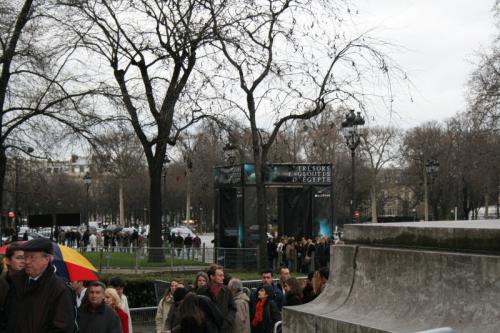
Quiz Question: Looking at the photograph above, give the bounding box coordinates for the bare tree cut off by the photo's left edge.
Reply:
[0,0,98,228]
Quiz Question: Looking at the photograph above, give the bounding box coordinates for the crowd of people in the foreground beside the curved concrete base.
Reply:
[156,265,329,333]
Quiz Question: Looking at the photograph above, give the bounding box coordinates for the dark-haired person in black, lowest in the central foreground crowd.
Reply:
[172,292,224,333]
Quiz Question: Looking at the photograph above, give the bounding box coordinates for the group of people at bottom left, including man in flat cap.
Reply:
[0,238,132,333]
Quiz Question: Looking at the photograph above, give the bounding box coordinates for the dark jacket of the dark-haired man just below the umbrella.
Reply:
[78,302,123,333]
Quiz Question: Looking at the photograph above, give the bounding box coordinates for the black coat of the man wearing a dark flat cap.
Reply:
[5,266,76,333]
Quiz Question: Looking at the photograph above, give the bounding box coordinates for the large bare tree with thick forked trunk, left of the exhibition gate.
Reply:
[59,0,229,260]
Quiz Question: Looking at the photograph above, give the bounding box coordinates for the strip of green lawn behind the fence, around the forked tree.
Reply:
[83,252,208,269]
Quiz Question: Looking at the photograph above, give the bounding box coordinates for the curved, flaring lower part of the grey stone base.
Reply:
[283,245,500,333]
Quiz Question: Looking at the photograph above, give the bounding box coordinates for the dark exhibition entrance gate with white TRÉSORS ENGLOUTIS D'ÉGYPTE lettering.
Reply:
[214,163,333,248]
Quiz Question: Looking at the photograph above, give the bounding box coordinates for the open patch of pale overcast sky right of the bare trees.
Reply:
[356,0,495,128]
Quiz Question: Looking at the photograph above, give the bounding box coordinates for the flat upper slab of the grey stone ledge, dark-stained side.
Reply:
[344,220,500,254]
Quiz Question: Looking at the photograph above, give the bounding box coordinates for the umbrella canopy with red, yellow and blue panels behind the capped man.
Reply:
[0,242,99,281]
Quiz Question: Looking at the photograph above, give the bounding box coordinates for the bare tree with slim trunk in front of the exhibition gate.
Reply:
[208,0,406,267]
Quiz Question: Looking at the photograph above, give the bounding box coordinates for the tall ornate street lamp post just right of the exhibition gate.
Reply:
[342,110,365,223]
